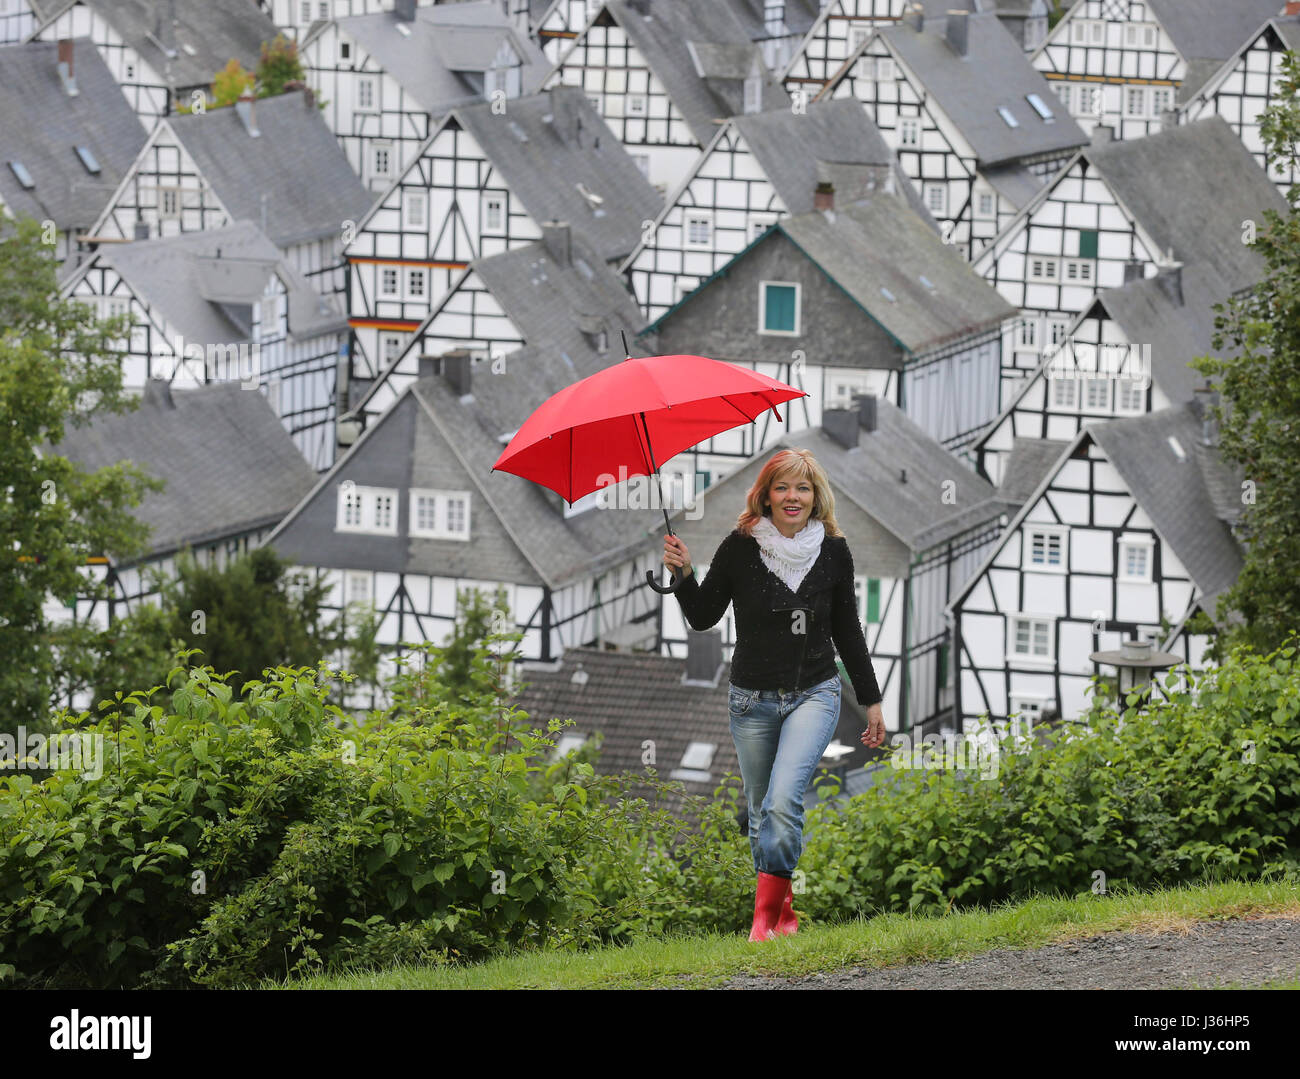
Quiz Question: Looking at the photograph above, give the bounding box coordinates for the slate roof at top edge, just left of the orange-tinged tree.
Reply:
[38,0,278,88]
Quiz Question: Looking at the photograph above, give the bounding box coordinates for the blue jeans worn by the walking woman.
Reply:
[728,673,840,876]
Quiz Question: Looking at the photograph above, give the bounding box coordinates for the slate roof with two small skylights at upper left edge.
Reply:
[0,38,147,239]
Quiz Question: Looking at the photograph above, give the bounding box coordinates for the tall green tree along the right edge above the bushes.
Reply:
[1191,52,1300,660]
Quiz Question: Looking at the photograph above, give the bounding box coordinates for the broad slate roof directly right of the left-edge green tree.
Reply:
[55,381,316,556]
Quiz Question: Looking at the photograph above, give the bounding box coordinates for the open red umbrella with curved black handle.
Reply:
[491,345,807,592]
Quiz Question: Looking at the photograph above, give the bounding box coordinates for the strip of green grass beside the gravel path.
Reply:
[259,881,1300,989]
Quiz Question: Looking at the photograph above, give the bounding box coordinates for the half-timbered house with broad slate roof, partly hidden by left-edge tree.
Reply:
[47,378,317,709]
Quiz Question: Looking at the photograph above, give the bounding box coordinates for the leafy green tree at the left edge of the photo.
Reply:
[0,218,159,731]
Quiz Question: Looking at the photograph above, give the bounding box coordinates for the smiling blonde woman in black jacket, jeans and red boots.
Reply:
[663,450,885,940]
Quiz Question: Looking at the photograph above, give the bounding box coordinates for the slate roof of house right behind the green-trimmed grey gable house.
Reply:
[738,100,911,213]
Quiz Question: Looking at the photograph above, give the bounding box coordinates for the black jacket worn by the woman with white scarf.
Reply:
[673,529,881,707]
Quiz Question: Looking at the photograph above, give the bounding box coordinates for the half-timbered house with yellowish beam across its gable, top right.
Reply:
[1032,0,1282,139]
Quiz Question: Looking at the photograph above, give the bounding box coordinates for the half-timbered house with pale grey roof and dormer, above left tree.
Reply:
[64,221,347,469]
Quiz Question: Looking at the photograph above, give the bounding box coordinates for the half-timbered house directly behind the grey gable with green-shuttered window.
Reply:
[620,101,919,320]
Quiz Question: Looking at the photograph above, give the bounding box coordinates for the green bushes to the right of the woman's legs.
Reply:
[800,642,1300,918]
